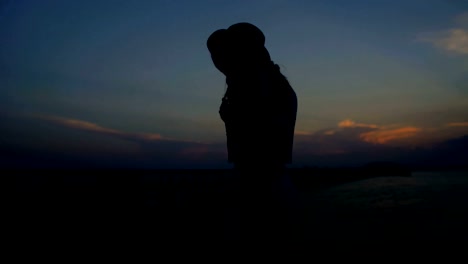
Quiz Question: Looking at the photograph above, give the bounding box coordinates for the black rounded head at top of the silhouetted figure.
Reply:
[207,22,271,76]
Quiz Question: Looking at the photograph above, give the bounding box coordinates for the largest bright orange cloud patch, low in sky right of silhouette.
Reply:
[360,127,421,144]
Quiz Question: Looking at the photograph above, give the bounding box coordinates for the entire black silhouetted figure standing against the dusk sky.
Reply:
[207,23,297,241]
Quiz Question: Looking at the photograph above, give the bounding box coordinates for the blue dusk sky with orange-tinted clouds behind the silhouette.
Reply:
[0,0,468,167]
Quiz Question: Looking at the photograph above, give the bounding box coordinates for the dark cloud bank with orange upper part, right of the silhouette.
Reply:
[294,119,468,167]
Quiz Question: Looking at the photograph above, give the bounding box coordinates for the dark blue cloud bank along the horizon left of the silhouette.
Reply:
[0,115,228,168]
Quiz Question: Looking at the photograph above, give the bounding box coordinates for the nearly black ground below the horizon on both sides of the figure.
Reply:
[2,170,468,242]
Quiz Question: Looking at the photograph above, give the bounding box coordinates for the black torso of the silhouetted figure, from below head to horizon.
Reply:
[220,65,297,168]
